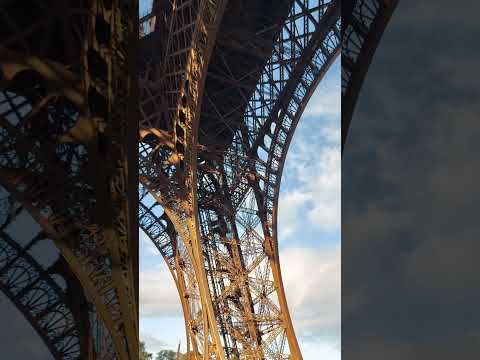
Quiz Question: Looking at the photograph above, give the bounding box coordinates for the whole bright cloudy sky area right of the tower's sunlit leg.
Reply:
[278,59,341,360]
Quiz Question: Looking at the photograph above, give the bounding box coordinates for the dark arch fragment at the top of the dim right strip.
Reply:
[342,0,399,152]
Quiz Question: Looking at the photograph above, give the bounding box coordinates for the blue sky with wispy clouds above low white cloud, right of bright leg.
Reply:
[278,57,341,243]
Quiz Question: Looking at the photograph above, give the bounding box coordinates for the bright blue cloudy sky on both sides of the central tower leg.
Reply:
[139,0,341,354]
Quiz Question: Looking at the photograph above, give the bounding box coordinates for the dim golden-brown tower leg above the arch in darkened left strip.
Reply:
[0,0,138,359]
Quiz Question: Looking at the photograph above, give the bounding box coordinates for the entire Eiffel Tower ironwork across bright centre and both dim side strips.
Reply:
[0,0,398,360]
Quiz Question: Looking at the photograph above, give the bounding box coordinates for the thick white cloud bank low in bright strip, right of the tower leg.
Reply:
[280,245,341,338]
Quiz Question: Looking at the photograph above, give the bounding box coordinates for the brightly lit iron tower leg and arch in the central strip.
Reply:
[139,0,341,359]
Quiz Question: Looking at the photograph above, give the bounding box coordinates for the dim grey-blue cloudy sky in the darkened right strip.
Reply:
[342,0,480,360]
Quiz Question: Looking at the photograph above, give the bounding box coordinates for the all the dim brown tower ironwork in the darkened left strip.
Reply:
[0,0,138,359]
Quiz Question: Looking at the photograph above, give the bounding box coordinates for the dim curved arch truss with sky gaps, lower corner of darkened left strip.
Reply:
[0,188,114,360]
